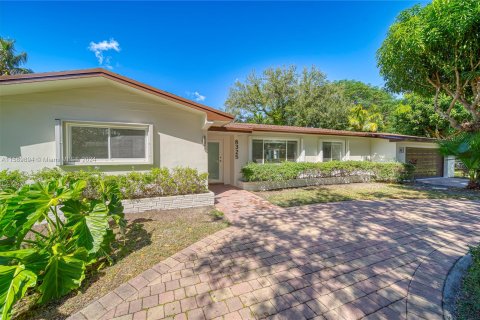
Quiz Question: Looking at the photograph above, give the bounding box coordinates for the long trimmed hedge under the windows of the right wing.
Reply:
[242,161,415,182]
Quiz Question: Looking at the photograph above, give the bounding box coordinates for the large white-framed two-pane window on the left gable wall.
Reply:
[66,122,151,163]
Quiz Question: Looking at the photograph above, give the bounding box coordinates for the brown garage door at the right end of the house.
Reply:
[406,148,443,178]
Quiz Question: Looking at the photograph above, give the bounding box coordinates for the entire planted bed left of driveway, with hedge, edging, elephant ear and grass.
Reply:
[0,168,220,320]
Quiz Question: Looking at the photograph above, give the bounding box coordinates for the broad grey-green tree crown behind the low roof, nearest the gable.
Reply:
[225,66,349,129]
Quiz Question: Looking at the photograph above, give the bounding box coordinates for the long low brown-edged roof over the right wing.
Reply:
[210,122,436,142]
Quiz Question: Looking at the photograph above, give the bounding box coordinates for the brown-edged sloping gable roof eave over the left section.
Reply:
[0,68,234,121]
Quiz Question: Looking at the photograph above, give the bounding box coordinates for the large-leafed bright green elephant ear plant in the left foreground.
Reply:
[0,178,126,319]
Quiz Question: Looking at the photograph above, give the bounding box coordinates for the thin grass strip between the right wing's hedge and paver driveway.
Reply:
[256,183,480,207]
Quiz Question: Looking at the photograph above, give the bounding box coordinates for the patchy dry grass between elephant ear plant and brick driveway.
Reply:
[14,207,228,320]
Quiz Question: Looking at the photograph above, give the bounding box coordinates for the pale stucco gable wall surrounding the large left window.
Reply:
[0,84,207,172]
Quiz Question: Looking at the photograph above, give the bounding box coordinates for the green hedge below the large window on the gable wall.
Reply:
[0,168,208,199]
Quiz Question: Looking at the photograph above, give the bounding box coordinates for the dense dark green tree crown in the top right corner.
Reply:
[377,0,480,131]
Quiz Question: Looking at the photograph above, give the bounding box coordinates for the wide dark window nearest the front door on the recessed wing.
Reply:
[251,139,298,163]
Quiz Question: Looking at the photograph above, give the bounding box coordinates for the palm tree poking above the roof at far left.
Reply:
[0,37,33,76]
